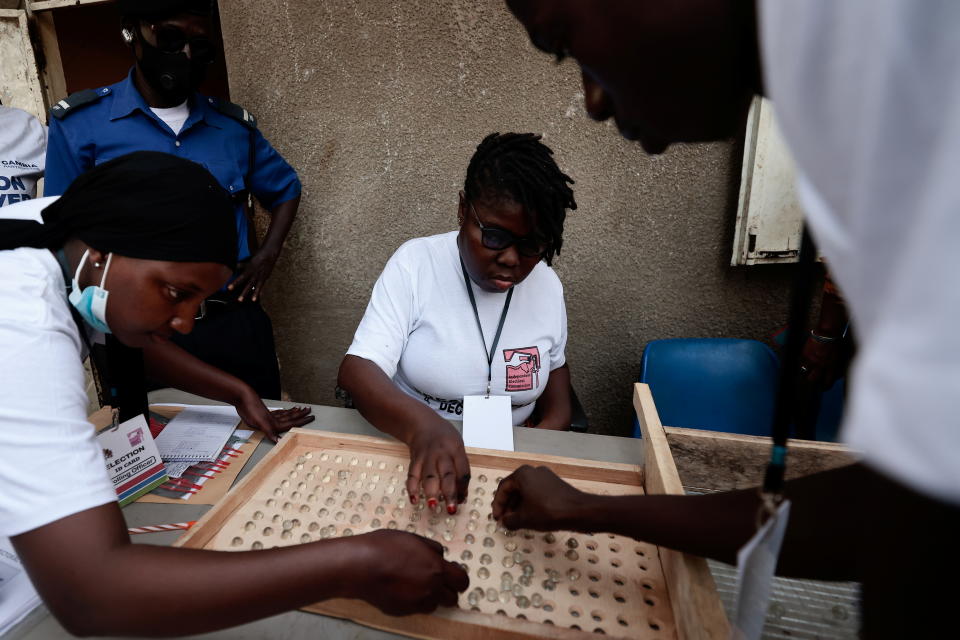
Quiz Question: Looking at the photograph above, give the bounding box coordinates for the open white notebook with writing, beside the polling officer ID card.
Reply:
[157,408,240,462]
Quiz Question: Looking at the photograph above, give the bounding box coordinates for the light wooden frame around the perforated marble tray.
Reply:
[175,384,730,640]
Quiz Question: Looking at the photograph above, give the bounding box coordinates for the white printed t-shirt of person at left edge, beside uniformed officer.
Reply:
[0,105,47,207]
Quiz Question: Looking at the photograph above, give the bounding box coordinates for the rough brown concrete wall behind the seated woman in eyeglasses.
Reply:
[221,0,788,434]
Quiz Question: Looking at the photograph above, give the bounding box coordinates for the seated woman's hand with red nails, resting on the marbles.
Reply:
[407,419,470,514]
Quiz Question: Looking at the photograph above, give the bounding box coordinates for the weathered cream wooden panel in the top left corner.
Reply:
[0,9,46,121]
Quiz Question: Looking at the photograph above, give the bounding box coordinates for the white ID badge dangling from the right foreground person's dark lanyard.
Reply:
[730,500,790,640]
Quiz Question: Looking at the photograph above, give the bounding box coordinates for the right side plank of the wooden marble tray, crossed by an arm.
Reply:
[633,383,730,640]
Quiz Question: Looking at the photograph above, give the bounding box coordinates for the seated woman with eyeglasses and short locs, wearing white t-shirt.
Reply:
[338,133,577,513]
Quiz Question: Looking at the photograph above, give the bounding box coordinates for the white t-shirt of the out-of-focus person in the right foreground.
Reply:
[760,0,960,504]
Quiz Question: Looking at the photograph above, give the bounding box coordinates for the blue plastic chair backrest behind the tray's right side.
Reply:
[634,338,779,436]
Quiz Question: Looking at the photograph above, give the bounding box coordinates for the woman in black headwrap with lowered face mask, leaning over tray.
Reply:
[0,152,467,635]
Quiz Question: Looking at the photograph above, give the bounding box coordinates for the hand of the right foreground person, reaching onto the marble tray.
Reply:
[493,464,589,531]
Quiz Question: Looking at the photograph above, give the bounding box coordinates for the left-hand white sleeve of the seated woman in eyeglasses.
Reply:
[347,246,417,379]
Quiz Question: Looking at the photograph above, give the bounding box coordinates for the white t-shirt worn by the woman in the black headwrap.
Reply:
[0,198,117,537]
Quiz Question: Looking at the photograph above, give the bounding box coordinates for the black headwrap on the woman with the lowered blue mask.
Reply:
[0,151,237,269]
